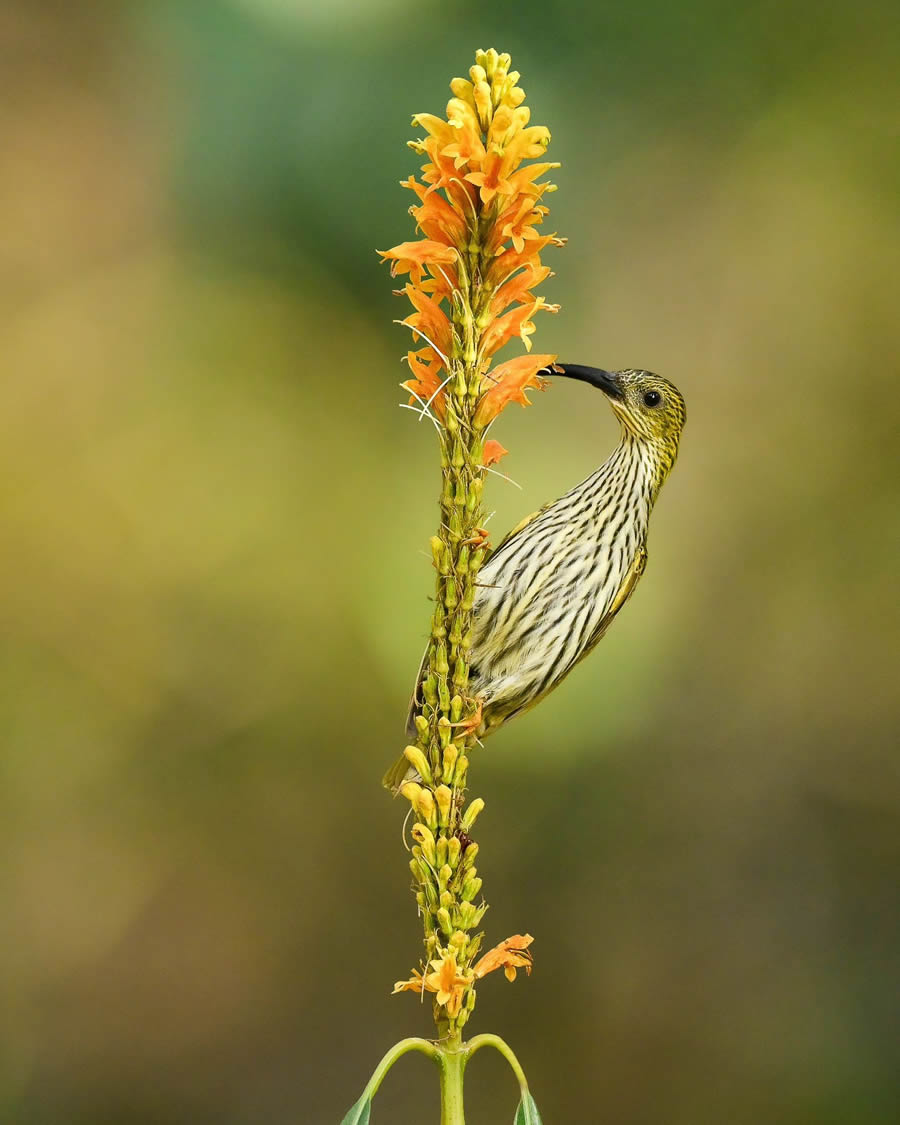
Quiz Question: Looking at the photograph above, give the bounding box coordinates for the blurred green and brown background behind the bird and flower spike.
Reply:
[0,0,900,1125]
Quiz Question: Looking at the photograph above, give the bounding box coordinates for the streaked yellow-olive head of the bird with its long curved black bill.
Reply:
[550,363,686,473]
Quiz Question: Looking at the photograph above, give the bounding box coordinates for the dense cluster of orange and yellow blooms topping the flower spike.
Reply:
[381,50,563,445]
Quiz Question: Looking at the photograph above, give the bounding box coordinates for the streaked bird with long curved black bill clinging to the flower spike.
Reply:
[384,363,686,792]
